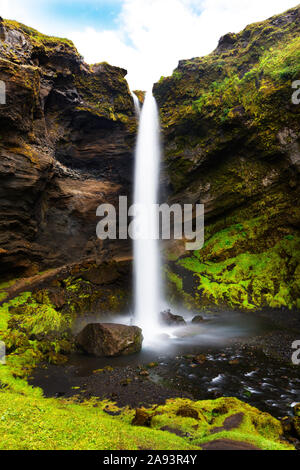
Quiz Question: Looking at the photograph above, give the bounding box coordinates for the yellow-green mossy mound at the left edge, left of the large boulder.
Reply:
[0,292,73,381]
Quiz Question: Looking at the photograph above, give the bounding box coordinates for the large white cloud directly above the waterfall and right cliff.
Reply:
[71,0,296,89]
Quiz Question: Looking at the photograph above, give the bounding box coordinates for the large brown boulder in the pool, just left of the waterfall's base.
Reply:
[76,323,143,357]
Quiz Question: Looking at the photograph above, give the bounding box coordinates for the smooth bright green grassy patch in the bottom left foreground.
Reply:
[0,391,195,450]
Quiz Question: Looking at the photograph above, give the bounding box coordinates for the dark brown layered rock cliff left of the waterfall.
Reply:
[0,20,136,278]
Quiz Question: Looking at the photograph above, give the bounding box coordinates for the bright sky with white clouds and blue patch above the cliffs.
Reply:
[0,0,299,90]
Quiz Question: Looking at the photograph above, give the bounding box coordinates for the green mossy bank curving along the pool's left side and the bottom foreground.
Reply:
[0,282,293,450]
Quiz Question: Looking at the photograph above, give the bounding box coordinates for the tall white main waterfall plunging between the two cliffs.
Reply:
[134,92,161,341]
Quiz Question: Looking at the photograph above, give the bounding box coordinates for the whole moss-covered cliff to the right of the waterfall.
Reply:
[154,6,300,309]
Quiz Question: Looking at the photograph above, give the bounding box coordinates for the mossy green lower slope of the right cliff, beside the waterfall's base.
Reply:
[167,206,300,310]
